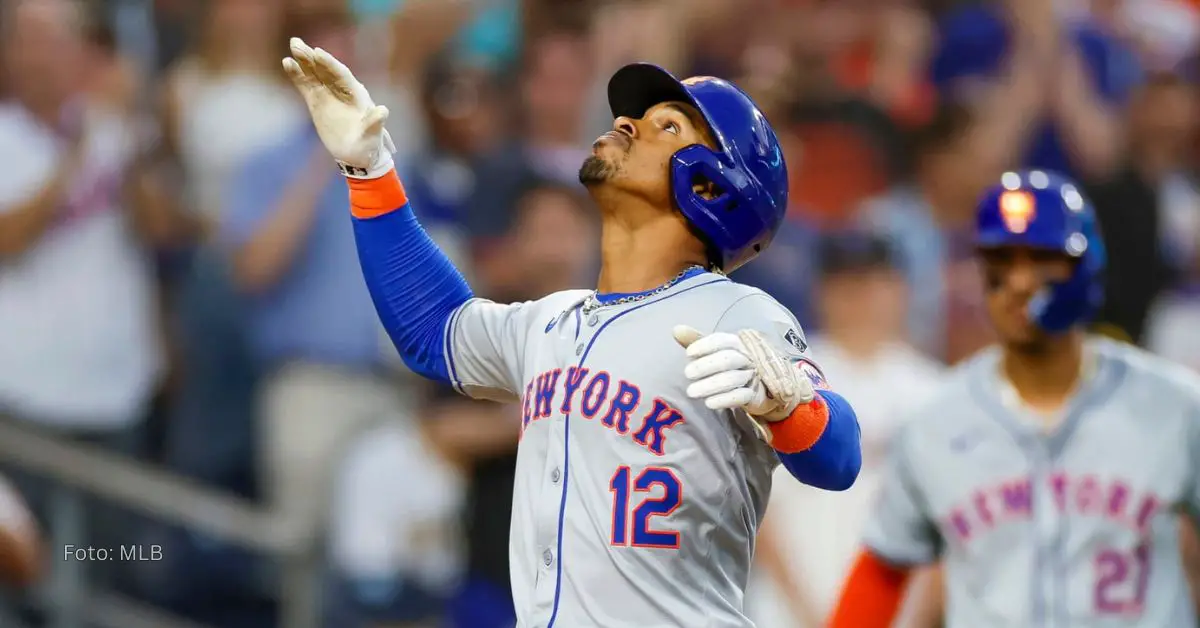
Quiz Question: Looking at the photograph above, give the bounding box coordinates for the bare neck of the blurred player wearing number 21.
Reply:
[1001,331,1084,412]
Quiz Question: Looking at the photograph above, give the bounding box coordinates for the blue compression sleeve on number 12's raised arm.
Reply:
[352,174,473,383]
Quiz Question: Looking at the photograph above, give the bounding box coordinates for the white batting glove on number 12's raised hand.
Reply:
[283,37,396,179]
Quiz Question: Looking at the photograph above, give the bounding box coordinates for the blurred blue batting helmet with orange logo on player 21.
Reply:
[976,171,1105,334]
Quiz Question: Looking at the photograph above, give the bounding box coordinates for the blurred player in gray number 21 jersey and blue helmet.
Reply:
[832,171,1200,628]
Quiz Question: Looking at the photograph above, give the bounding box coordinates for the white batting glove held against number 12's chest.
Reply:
[672,325,816,432]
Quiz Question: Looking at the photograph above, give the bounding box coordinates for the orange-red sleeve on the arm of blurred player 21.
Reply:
[827,551,908,628]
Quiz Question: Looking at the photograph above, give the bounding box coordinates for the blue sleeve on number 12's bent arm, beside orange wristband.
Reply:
[776,390,863,491]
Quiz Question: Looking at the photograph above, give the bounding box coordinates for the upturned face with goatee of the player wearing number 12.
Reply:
[580,102,716,208]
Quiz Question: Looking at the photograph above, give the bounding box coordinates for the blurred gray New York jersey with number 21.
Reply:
[866,339,1200,628]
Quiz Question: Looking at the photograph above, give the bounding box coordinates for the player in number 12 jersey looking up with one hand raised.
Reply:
[284,40,860,628]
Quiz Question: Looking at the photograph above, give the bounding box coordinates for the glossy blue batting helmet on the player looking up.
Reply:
[608,64,787,273]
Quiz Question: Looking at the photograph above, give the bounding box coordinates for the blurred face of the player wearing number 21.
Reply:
[979,246,1075,345]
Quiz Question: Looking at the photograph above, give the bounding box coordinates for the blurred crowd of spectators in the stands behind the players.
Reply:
[0,0,1200,628]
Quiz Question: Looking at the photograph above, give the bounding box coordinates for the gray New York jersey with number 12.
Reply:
[445,273,815,628]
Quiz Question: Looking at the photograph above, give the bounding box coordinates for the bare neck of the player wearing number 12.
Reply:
[596,206,704,294]
